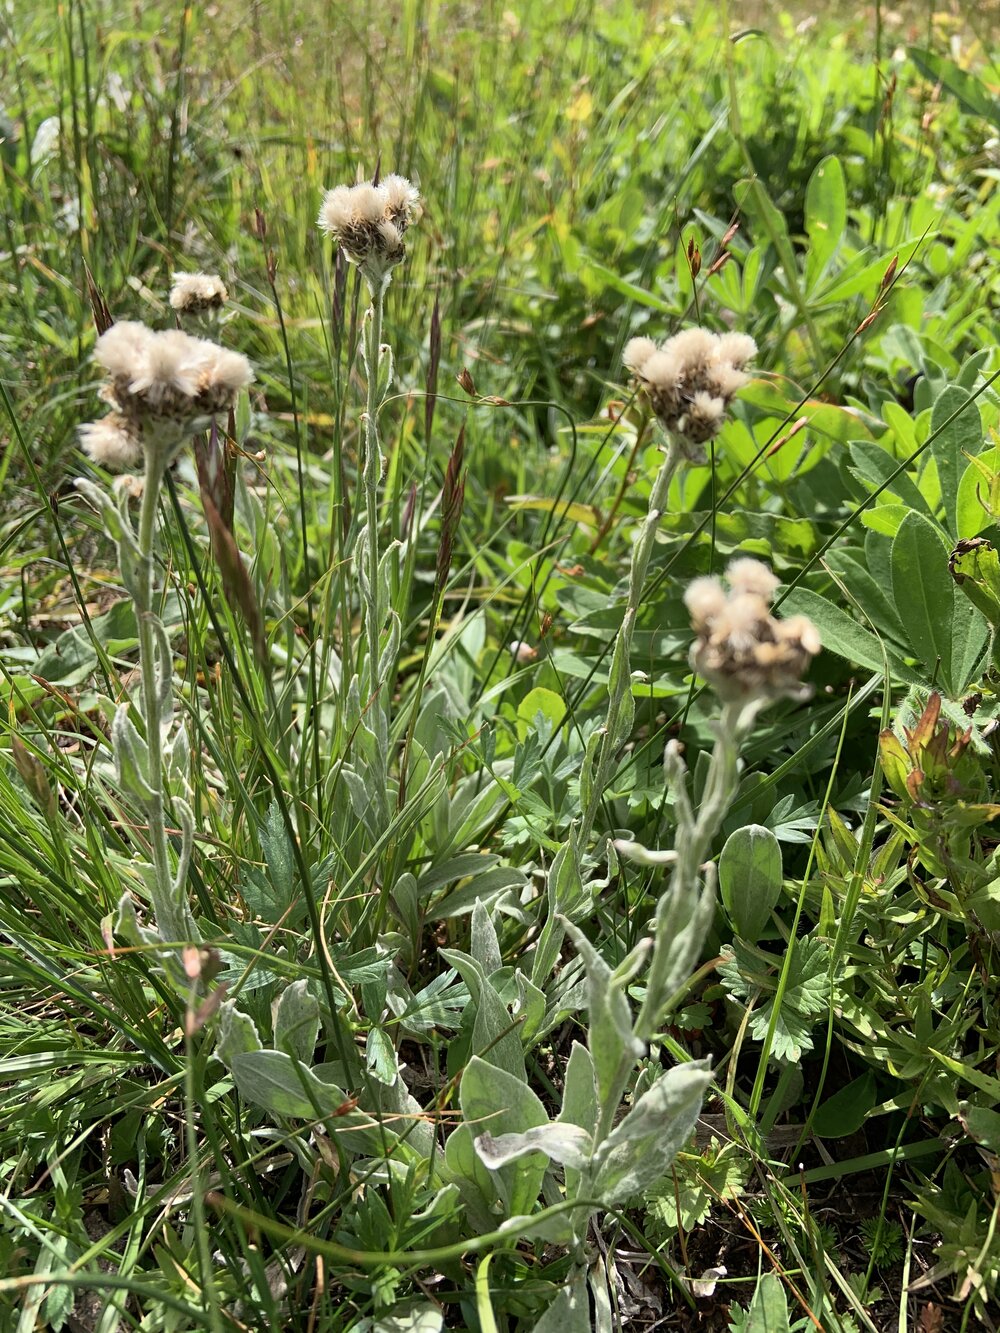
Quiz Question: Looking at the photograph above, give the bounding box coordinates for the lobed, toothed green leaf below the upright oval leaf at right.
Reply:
[719,940,829,1061]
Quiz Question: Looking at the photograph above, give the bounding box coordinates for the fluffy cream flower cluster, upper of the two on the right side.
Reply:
[624,328,757,448]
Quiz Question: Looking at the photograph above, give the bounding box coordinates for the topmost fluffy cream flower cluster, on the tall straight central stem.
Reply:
[319,176,420,275]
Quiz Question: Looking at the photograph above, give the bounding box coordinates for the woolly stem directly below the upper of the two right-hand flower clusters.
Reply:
[580,435,681,848]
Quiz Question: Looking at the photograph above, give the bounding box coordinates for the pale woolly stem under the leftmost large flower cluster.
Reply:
[132,448,200,941]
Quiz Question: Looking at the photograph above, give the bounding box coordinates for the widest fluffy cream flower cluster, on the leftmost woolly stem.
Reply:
[80,320,253,468]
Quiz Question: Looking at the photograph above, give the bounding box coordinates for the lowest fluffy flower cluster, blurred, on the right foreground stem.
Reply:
[684,557,820,701]
